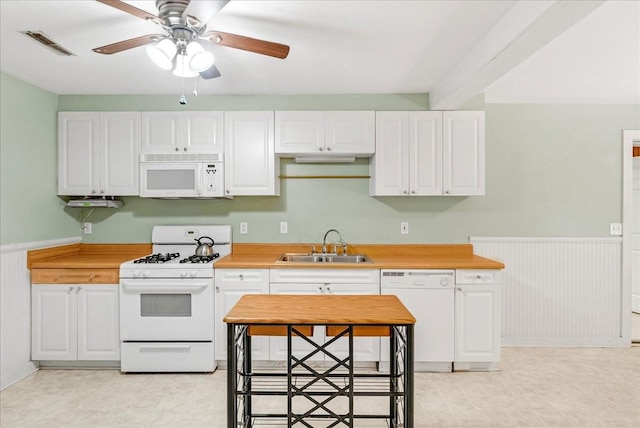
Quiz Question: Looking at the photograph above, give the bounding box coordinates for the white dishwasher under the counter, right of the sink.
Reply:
[380,269,455,372]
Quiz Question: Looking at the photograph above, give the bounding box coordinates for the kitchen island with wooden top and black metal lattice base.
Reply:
[224,294,415,428]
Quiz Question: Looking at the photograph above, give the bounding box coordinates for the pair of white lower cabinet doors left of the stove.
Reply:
[31,284,120,361]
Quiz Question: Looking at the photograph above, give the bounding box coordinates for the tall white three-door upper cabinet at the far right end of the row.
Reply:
[369,111,484,196]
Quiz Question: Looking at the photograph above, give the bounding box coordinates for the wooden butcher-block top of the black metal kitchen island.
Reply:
[223,294,416,326]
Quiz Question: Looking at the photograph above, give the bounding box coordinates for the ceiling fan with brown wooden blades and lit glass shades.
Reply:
[93,0,289,79]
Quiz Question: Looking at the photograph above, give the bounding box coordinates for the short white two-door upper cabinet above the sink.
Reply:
[275,111,375,157]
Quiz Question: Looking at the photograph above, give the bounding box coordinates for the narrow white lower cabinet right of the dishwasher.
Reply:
[454,270,502,370]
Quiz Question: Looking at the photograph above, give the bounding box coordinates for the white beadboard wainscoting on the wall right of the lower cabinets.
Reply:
[469,237,631,346]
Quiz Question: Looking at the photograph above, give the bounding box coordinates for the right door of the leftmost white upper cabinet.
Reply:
[99,112,140,196]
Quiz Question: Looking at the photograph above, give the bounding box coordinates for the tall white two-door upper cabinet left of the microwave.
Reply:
[58,112,140,196]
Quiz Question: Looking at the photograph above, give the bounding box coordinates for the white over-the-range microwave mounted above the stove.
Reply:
[140,153,224,198]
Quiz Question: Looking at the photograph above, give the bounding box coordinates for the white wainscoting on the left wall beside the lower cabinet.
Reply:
[0,238,80,390]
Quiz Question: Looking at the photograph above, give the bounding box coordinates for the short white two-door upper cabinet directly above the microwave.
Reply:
[142,111,224,154]
